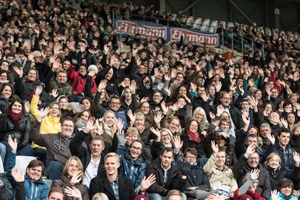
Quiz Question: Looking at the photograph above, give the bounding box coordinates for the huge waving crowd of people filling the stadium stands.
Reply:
[0,0,300,200]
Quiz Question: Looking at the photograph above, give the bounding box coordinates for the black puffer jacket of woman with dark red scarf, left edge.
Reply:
[0,114,30,149]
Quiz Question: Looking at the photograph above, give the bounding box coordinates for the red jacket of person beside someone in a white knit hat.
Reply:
[67,65,97,95]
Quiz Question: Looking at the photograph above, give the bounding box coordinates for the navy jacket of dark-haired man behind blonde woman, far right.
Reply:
[265,143,295,172]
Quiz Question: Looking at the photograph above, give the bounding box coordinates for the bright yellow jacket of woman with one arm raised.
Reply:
[30,95,61,149]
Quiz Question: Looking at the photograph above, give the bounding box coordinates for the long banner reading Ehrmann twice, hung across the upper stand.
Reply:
[114,20,220,47]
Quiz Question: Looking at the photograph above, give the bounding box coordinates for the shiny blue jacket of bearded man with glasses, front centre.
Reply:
[116,145,147,189]
